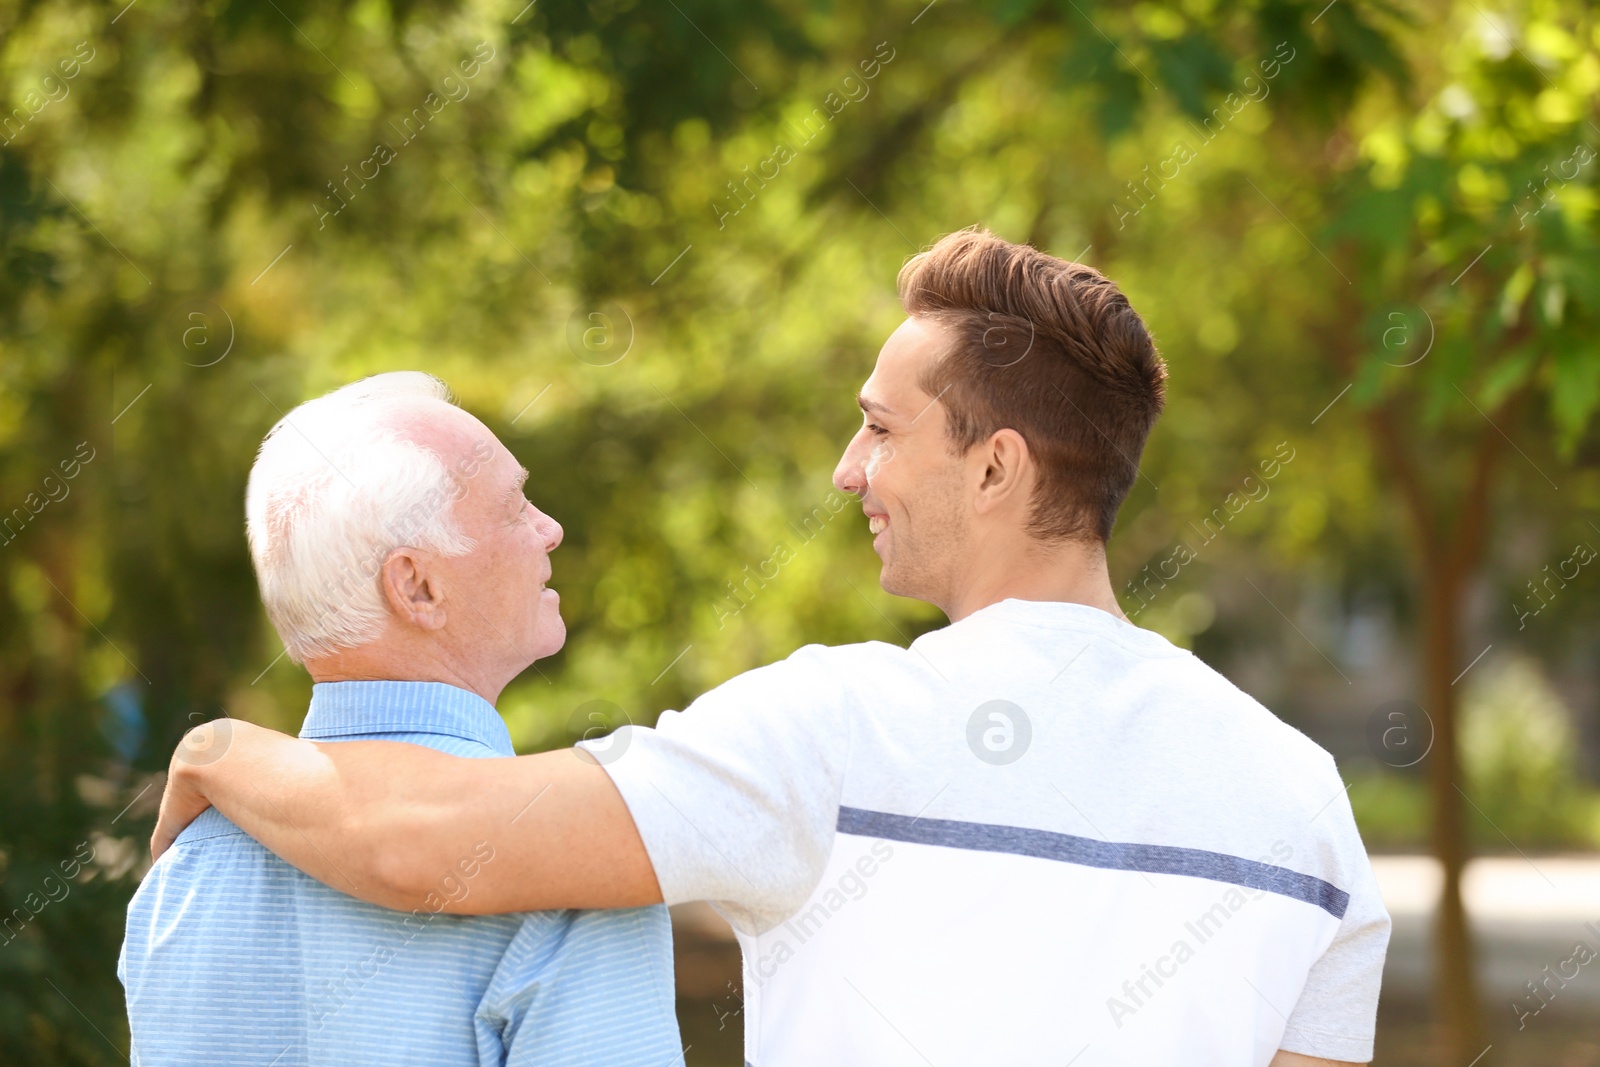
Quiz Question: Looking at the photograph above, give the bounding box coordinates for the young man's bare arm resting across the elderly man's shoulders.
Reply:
[150,720,661,915]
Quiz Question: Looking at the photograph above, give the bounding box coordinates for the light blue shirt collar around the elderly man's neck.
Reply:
[301,681,515,755]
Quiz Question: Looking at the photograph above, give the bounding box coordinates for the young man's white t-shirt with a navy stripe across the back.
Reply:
[589,600,1389,1067]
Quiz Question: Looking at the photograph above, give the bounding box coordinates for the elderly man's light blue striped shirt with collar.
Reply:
[117,681,683,1067]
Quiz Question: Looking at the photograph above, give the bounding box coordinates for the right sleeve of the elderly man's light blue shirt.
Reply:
[475,904,683,1067]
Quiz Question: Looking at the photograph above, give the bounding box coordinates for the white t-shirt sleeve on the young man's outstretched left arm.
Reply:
[579,645,850,936]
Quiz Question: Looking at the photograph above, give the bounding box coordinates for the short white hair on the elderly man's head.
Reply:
[245,371,486,662]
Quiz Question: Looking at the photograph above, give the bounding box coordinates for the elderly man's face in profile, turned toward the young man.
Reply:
[400,403,566,677]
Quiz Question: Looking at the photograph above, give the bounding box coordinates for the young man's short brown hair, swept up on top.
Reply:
[899,227,1166,542]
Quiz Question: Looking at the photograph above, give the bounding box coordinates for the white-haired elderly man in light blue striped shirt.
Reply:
[118,373,680,1067]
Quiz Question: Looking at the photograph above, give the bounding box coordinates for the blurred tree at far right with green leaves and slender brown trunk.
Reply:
[1291,3,1600,1059]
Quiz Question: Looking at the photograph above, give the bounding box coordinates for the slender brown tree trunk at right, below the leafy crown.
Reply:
[1422,555,1485,1067]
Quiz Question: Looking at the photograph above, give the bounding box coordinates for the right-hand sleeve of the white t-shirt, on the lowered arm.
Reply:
[1280,783,1389,1064]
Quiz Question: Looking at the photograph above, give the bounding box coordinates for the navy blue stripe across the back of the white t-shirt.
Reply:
[838,808,1350,918]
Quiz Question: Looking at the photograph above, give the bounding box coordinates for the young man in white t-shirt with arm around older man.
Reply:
[152,230,1389,1067]
